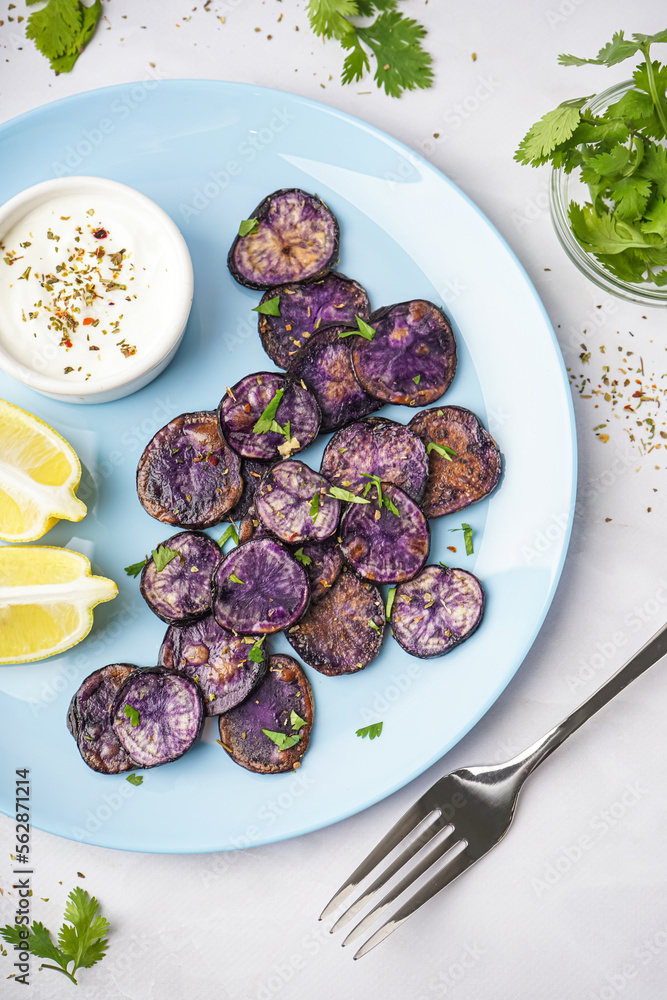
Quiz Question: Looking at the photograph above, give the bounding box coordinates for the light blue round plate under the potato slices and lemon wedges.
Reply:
[0,80,576,852]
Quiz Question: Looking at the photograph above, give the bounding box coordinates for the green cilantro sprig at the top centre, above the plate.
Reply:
[308,0,433,97]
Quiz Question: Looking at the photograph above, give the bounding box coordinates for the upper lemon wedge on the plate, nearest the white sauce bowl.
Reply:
[0,399,86,542]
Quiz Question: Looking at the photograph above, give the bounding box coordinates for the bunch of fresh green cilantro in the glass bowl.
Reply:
[515,30,667,285]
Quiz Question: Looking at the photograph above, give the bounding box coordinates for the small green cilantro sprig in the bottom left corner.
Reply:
[0,886,110,986]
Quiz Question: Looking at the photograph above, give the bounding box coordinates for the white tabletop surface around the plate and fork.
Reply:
[0,0,667,1000]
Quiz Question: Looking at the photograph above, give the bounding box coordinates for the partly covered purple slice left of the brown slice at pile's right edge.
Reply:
[320,417,428,502]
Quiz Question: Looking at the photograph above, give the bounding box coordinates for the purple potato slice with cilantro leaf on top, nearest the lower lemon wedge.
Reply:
[140,531,222,625]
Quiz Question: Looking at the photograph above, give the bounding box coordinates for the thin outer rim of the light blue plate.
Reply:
[0,77,578,855]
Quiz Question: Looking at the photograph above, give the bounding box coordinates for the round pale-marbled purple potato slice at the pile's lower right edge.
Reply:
[391,566,484,657]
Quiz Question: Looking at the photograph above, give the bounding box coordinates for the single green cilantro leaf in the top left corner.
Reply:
[26,0,102,76]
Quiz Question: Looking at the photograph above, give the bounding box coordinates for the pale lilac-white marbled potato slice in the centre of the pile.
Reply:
[255,459,340,545]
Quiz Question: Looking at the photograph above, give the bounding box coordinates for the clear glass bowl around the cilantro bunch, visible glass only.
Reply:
[549,80,667,306]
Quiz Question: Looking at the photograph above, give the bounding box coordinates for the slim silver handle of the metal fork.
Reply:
[505,625,667,777]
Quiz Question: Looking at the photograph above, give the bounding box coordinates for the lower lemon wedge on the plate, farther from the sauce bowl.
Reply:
[0,545,118,664]
